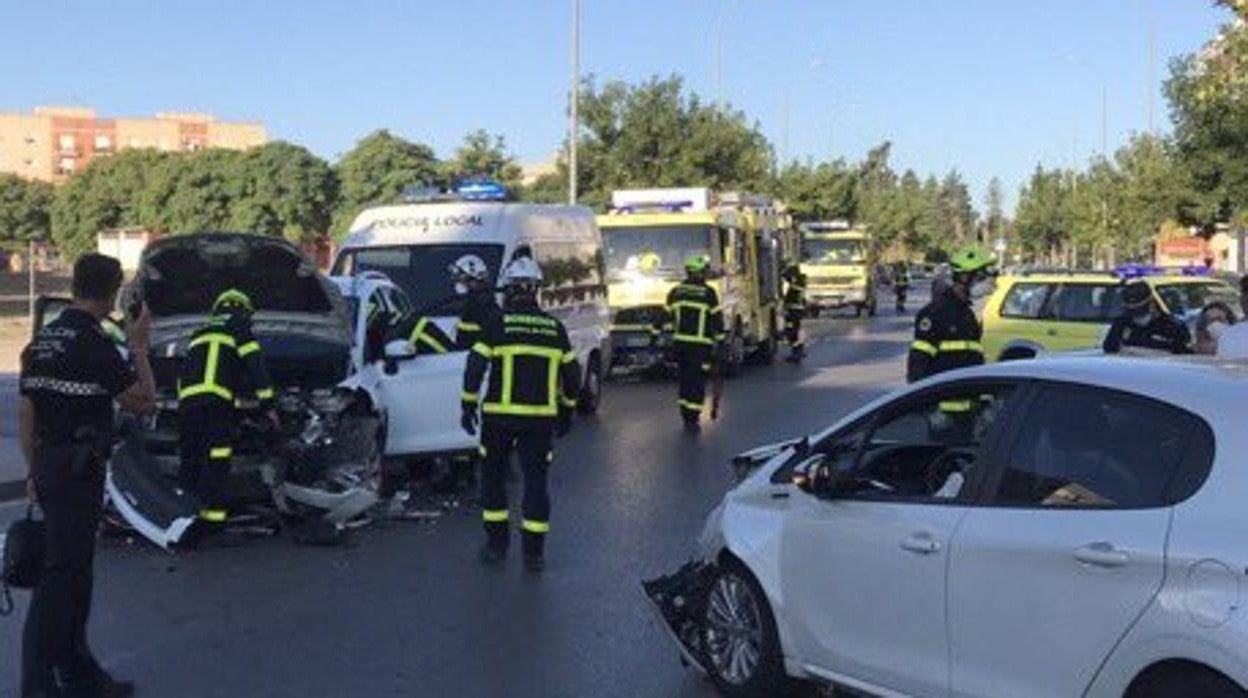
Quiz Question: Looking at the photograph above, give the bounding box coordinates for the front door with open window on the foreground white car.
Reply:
[781,385,1012,696]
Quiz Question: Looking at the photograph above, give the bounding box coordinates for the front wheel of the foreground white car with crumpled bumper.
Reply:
[701,559,790,698]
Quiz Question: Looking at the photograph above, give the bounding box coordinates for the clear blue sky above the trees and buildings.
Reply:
[0,0,1227,213]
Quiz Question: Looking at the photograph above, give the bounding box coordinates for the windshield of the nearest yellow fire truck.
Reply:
[603,225,711,281]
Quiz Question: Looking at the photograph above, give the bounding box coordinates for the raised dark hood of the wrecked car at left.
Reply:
[126,232,352,387]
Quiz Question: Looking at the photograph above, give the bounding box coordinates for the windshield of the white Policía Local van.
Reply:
[333,243,503,316]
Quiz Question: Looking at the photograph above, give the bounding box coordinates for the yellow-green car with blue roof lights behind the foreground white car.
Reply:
[983,271,1239,361]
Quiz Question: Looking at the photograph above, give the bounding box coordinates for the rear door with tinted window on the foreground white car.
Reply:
[948,386,1196,698]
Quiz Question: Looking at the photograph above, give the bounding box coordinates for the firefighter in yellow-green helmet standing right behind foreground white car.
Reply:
[906,247,993,384]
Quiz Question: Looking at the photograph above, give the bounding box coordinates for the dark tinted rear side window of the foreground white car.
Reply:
[992,385,1213,508]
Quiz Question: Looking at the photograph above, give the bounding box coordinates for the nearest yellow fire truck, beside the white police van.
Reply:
[598,187,799,373]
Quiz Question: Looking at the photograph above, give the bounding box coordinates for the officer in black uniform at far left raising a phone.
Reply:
[19,253,156,697]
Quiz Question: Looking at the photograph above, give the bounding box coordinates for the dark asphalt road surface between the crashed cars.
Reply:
[0,293,915,698]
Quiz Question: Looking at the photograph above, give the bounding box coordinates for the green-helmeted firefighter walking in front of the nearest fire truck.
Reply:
[668,255,725,433]
